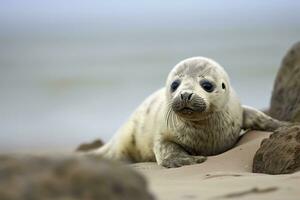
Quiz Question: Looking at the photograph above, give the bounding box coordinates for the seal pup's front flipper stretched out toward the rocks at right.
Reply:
[242,106,290,131]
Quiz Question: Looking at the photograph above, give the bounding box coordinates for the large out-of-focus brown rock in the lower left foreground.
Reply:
[0,155,153,200]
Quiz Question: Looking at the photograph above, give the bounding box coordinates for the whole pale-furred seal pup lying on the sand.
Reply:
[91,57,285,168]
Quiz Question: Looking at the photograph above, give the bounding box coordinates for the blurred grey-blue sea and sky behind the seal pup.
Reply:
[0,0,300,152]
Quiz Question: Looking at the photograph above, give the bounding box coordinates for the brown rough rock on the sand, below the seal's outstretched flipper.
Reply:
[253,125,300,174]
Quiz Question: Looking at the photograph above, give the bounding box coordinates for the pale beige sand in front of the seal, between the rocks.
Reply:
[131,131,300,200]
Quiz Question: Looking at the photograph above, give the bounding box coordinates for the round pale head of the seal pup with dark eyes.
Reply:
[166,57,230,121]
